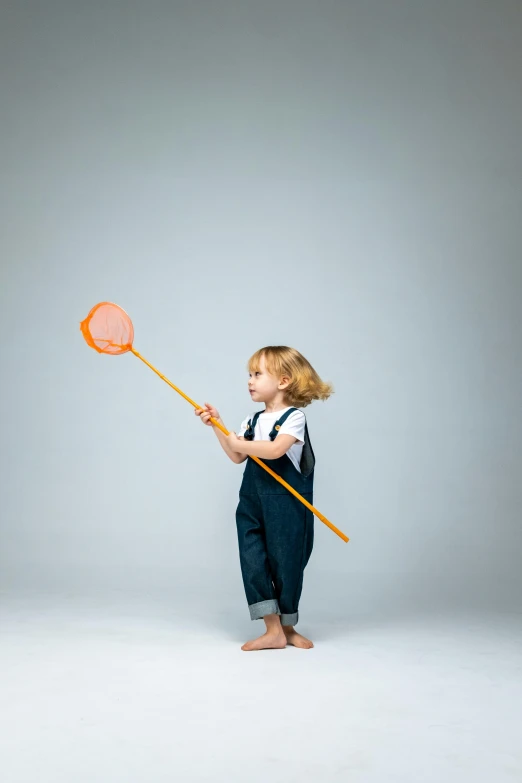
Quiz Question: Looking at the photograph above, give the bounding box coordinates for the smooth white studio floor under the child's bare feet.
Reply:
[0,591,522,783]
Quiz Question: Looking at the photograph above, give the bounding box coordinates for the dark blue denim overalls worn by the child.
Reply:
[236,408,315,625]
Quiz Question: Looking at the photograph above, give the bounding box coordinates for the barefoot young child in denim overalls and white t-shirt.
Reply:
[195,346,333,651]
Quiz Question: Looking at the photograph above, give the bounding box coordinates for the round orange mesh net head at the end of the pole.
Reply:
[80,302,134,356]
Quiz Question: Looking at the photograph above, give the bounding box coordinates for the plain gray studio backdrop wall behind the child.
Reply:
[0,0,522,619]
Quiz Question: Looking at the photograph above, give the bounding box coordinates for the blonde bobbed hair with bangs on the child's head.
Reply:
[248,345,334,408]
